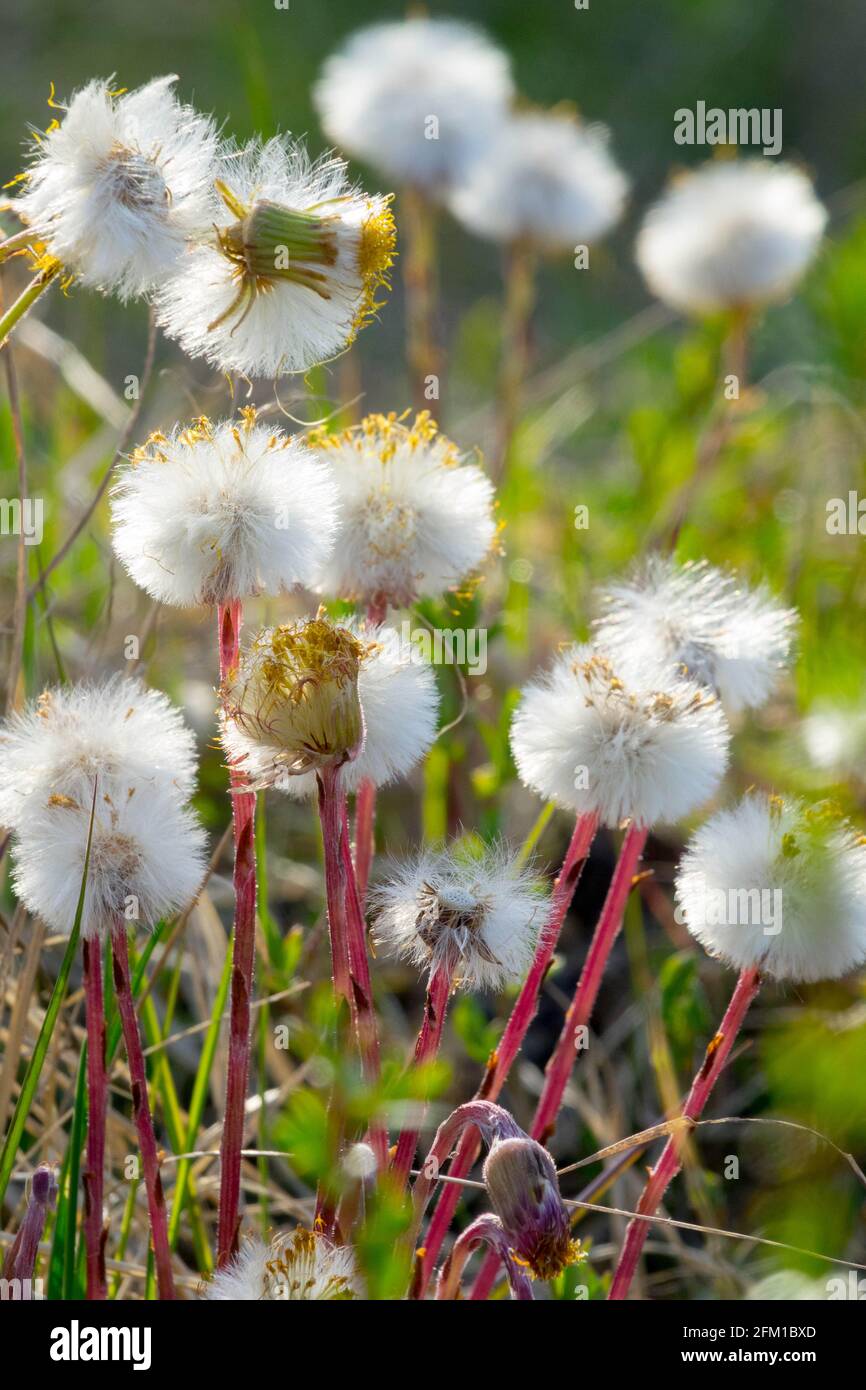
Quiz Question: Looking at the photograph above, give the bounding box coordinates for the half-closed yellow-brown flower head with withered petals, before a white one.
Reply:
[221,616,364,788]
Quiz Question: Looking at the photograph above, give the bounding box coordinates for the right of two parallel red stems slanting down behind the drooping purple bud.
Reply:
[473,824,649,1298]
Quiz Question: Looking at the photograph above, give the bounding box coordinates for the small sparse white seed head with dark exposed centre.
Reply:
[371,845,546,990]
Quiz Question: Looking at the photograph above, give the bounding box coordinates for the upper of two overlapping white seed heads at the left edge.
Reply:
[0,676,196,830]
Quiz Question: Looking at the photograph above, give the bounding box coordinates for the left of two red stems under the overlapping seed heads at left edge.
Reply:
[82,937,108,1300]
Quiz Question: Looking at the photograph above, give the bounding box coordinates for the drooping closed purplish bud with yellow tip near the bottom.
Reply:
[484,1134,581,1279]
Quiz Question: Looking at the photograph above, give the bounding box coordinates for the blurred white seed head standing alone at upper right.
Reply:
[635,158,827,314]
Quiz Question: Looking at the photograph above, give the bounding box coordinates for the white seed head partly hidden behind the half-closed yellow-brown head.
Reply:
[268,619,439,798]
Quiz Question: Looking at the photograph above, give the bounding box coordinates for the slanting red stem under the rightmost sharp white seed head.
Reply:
[607,969,760,1301]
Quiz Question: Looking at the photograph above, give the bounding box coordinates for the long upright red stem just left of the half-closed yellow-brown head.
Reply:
[217,600,256,1268]
